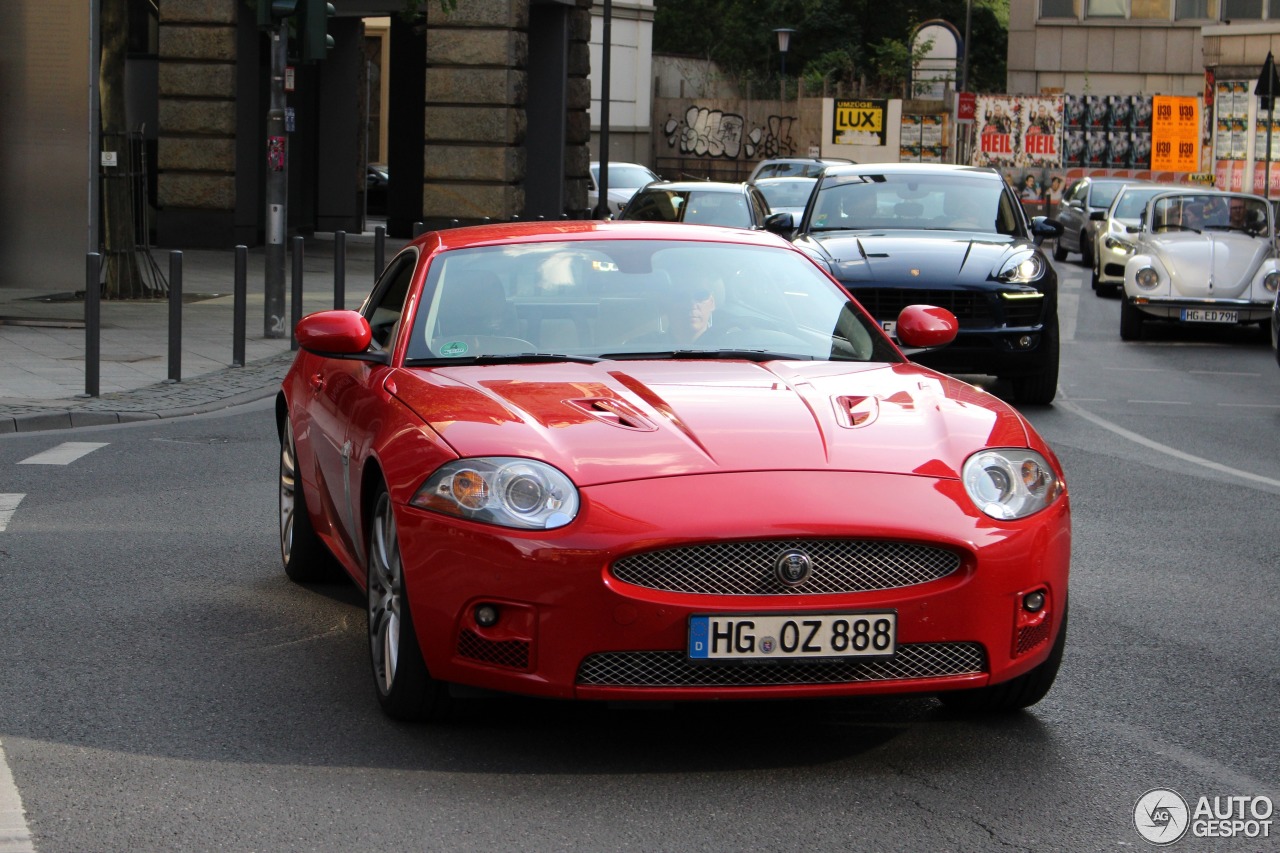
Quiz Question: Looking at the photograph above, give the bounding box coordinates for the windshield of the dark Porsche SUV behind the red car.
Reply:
[809,173,1023,234]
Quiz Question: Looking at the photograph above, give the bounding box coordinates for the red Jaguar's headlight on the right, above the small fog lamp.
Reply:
[960,448,1062,520]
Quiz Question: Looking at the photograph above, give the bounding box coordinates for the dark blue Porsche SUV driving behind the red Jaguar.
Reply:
[795,163,1061,405]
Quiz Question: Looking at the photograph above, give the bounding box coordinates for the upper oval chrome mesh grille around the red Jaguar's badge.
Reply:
[611,539,960,596]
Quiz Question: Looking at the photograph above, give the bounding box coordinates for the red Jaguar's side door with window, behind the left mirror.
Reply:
[308,248,419,560]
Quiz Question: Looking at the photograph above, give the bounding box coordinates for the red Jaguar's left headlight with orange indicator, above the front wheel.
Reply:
[410,456,579,530]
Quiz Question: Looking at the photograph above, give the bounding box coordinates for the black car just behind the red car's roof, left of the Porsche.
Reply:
[618,181,791,231]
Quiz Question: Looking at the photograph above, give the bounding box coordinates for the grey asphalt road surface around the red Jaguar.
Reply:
[0,258,1280,853]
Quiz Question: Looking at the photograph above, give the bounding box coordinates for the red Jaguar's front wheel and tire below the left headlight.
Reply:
[367,485,448,721]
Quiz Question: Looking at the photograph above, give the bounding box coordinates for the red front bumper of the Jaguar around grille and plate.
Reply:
[398,471,1070,701]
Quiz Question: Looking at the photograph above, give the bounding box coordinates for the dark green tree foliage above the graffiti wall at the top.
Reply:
[653,0,1009,96]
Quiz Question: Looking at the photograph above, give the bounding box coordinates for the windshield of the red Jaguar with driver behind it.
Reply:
[407,240,901,362]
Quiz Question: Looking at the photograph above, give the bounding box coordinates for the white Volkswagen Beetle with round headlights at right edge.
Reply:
[1120,190,1280,341]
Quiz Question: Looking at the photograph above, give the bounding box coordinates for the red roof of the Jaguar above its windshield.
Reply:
[410,219,803,254]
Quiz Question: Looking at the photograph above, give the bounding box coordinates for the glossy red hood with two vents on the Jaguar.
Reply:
[387,361,1028,484]
